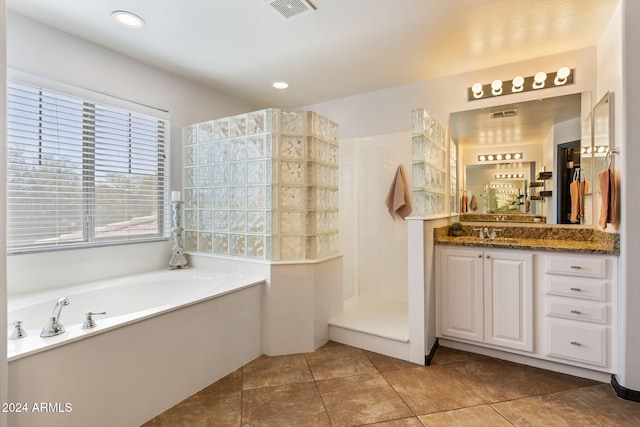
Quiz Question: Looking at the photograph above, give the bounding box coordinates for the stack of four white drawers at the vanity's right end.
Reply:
[544,254,616,370]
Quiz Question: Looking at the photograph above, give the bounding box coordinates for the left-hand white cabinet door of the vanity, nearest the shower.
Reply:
[437,248,484,342]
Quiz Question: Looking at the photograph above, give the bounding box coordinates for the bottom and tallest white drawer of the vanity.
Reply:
[547,320,607,367]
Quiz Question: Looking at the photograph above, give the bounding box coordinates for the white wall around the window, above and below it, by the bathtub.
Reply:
[2,13,256,293]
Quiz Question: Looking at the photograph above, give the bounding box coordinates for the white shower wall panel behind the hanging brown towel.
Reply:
[340,131,412,303]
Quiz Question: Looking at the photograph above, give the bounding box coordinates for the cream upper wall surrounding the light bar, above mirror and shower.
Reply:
[303,48,596,138]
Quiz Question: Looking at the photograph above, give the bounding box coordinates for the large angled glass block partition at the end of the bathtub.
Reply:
[183,108,339,260]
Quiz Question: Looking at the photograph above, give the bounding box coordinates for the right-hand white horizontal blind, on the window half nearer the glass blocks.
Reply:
[94,105,165,240]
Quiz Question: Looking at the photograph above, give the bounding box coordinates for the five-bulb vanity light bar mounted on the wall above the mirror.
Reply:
[467,67,575,101]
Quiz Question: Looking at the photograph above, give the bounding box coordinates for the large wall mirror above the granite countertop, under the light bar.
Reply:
[449,93,591,223]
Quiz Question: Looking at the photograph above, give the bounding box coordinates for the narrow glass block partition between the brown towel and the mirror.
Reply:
[411,109,449,216]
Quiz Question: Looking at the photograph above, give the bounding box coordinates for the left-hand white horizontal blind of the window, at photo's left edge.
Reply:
[7,83,84,248]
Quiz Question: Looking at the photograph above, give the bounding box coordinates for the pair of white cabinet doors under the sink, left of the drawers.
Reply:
[436,246,534,352]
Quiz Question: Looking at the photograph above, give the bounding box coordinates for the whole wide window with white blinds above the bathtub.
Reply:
[7,82,169,251]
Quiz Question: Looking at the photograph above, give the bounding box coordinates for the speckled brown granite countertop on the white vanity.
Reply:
[434,222,620,255]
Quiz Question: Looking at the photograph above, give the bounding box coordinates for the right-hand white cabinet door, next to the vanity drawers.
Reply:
[484,251,533,351]
